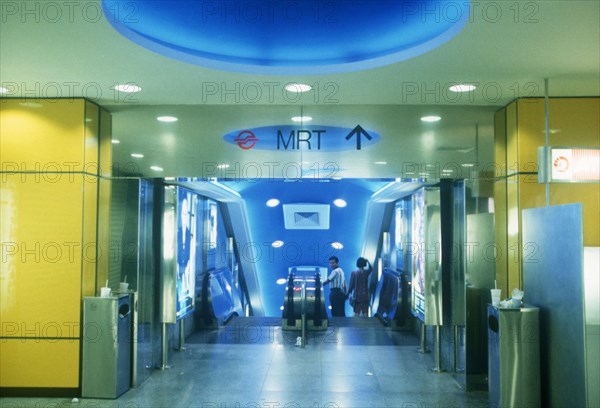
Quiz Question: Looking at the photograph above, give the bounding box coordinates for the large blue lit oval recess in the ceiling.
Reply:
[102,0,470,75]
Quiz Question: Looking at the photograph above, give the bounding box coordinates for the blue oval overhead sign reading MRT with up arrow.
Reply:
[223,125,380,152]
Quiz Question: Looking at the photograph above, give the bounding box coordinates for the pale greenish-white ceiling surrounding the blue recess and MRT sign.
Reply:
[0,0,600,177]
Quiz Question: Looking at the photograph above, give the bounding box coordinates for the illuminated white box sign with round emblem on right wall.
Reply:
[538,146,600,183]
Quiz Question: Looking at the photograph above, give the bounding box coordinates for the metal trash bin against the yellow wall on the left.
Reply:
[81,294,132,398]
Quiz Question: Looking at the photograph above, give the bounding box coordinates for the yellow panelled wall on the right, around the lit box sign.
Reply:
[494,98,600,291]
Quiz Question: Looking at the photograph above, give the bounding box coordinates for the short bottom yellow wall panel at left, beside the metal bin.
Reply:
[0,339,80,388]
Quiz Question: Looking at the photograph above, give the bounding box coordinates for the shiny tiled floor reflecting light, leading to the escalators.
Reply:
[0,317,488,408]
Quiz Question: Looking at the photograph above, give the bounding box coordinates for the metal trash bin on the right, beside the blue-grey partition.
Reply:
[488,305,541,408]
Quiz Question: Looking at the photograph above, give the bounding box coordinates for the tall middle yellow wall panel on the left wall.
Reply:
[0,174,82,337]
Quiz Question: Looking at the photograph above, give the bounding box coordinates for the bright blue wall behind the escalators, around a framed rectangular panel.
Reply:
[222,179,389,316]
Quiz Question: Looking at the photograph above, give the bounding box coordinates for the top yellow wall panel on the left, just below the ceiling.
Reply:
[0,98,84,173]
